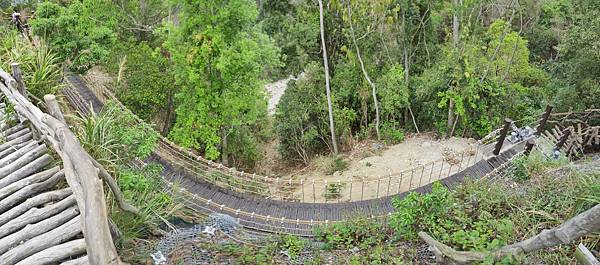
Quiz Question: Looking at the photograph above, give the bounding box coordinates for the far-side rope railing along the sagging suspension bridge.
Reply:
[64,73,544,203]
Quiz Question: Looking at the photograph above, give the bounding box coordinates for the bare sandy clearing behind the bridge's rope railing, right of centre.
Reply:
[280,136,481,202]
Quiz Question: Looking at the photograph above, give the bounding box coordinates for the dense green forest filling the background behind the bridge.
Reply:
[3,0,600,170]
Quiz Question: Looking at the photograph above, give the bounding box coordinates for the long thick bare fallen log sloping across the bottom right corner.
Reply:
[419,204,600,264]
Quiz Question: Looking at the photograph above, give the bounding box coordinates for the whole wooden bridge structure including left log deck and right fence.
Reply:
[0,64,600,264]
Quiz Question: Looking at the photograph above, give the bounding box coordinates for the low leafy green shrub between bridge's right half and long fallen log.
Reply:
[390,182,513,251]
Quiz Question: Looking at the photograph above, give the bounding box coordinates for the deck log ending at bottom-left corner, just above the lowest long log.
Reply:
[0,215,81,264]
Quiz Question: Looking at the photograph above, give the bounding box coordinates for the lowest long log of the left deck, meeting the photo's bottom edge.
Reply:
[15,238,85,265]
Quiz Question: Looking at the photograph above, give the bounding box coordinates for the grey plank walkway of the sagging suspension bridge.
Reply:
[63,74,522,236]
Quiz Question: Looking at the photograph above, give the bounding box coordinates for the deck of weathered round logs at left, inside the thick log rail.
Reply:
[0,106,87,265]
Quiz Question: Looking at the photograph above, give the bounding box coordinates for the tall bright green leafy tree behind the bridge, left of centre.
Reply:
[168,0,279,163]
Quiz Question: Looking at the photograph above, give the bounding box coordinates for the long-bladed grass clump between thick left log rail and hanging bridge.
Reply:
[77,102,158,169]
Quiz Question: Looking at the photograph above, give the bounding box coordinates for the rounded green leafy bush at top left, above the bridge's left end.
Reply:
[31,0,116,72]
